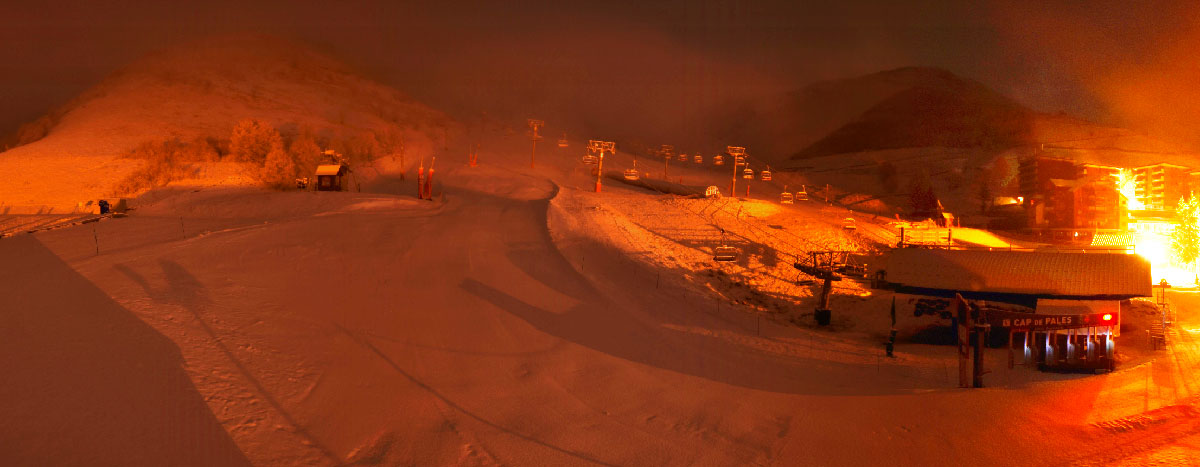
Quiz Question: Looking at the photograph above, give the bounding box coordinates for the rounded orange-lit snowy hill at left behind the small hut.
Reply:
[0,36,449,209]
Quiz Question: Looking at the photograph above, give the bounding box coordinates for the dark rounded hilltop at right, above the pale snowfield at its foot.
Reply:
[728,67,1178,167]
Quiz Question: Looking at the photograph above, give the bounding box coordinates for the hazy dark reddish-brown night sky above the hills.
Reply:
[0,0,1200,146]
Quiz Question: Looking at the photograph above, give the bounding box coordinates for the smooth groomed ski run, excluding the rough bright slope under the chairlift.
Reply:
[7,158,1200,465]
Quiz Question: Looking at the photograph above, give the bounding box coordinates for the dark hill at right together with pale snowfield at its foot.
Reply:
[729,67,1200,218]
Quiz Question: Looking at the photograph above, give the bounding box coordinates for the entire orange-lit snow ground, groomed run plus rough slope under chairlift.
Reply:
[0,129,1200,466]
